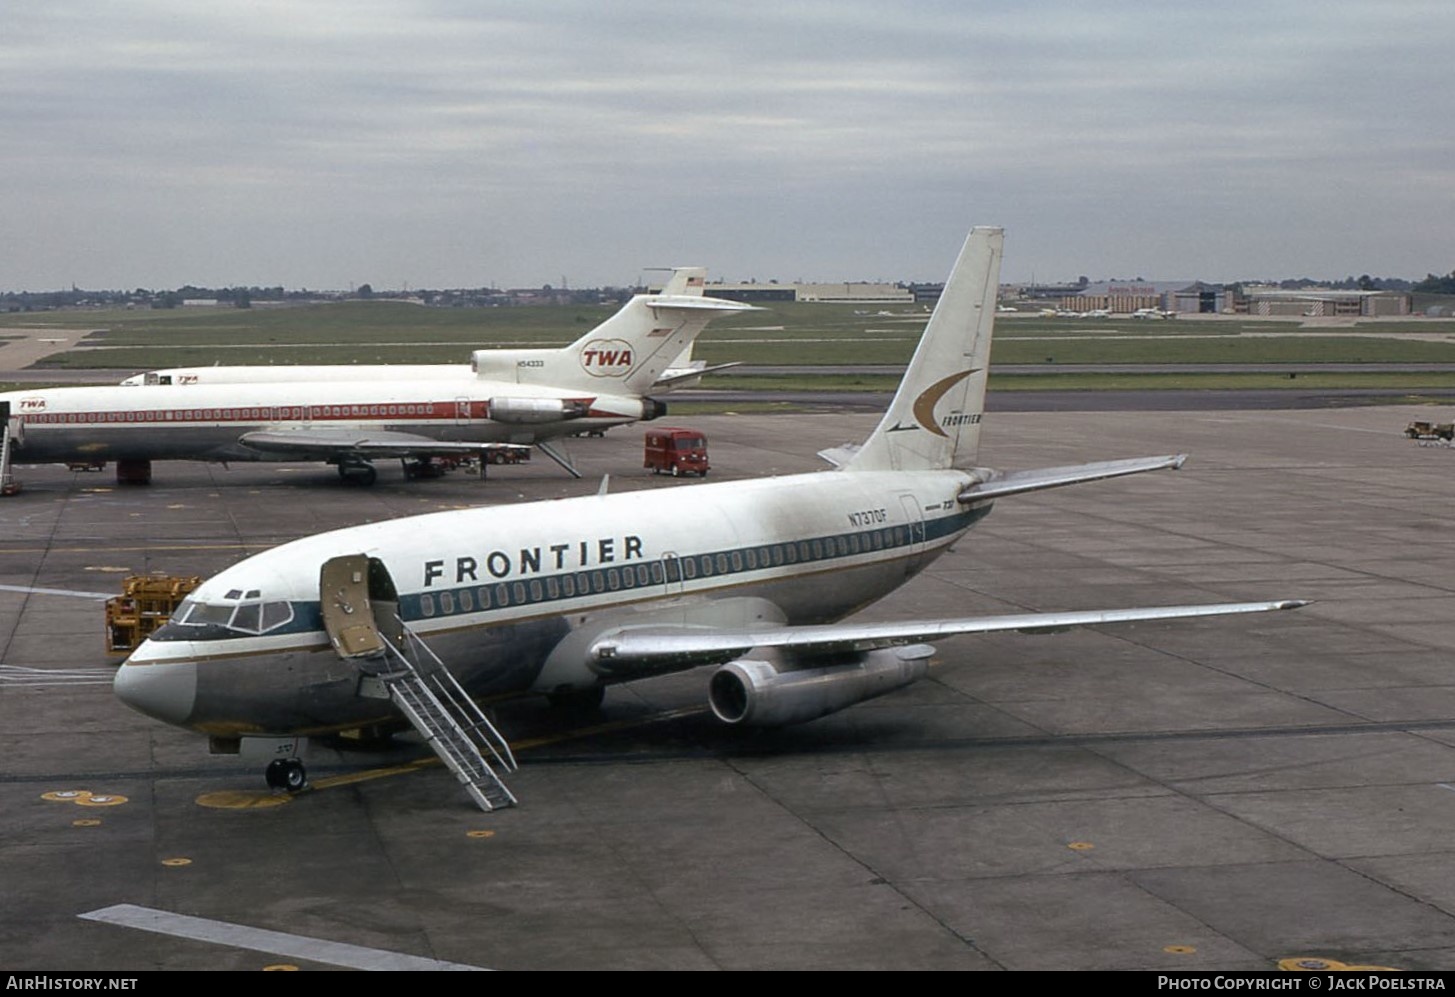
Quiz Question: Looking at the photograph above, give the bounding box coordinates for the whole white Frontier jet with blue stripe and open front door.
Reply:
[115,229,1301,809]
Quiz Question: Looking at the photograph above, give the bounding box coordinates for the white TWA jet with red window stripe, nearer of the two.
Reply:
[0,270,751,483]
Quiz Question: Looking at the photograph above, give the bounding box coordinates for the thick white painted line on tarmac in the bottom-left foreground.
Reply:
[77,904,485,972]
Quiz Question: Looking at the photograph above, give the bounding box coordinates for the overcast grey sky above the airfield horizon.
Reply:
[0,0,1455,290]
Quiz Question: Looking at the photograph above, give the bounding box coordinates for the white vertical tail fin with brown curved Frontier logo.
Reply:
[844,227,1005,470]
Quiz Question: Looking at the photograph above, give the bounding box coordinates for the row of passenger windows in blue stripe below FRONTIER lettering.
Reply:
[419,527,909,616]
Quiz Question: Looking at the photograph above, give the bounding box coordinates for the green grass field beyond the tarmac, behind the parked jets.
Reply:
[8,301,1455,372]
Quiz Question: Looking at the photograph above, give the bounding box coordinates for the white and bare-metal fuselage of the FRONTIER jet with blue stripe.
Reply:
[116,470,989,736]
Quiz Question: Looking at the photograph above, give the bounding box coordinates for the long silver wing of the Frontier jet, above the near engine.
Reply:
[589,600,1308,674]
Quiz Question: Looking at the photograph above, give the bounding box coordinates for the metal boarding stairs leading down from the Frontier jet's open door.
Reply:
[378,626,518,812]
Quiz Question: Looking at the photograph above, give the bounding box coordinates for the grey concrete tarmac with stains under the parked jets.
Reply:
[8,406,1455,971]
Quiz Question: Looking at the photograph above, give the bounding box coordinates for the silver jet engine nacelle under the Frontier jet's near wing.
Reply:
[707,643,934,726]
